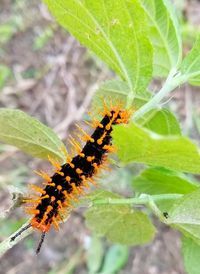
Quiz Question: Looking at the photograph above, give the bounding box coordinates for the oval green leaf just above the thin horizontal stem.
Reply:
[133,168,198,195]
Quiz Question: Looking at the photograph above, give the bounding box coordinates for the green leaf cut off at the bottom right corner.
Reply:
[182,237,200,274]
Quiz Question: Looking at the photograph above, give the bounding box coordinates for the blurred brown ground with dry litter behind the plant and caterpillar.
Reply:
[0,0,200,274]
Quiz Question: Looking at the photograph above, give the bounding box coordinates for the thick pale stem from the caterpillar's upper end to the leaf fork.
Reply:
[133,69,186,120]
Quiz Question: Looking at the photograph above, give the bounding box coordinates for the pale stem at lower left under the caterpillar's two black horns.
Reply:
[0,220,33,258]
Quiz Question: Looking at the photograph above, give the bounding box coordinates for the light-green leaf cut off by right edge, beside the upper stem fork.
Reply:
[181,35,200,86]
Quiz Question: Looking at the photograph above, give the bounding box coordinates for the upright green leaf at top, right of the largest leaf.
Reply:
[141,0,182,77]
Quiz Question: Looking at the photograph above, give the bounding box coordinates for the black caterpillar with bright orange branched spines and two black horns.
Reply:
[11,104,131,254]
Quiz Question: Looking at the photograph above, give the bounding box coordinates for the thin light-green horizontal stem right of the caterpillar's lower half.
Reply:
[92,194,183,205]
